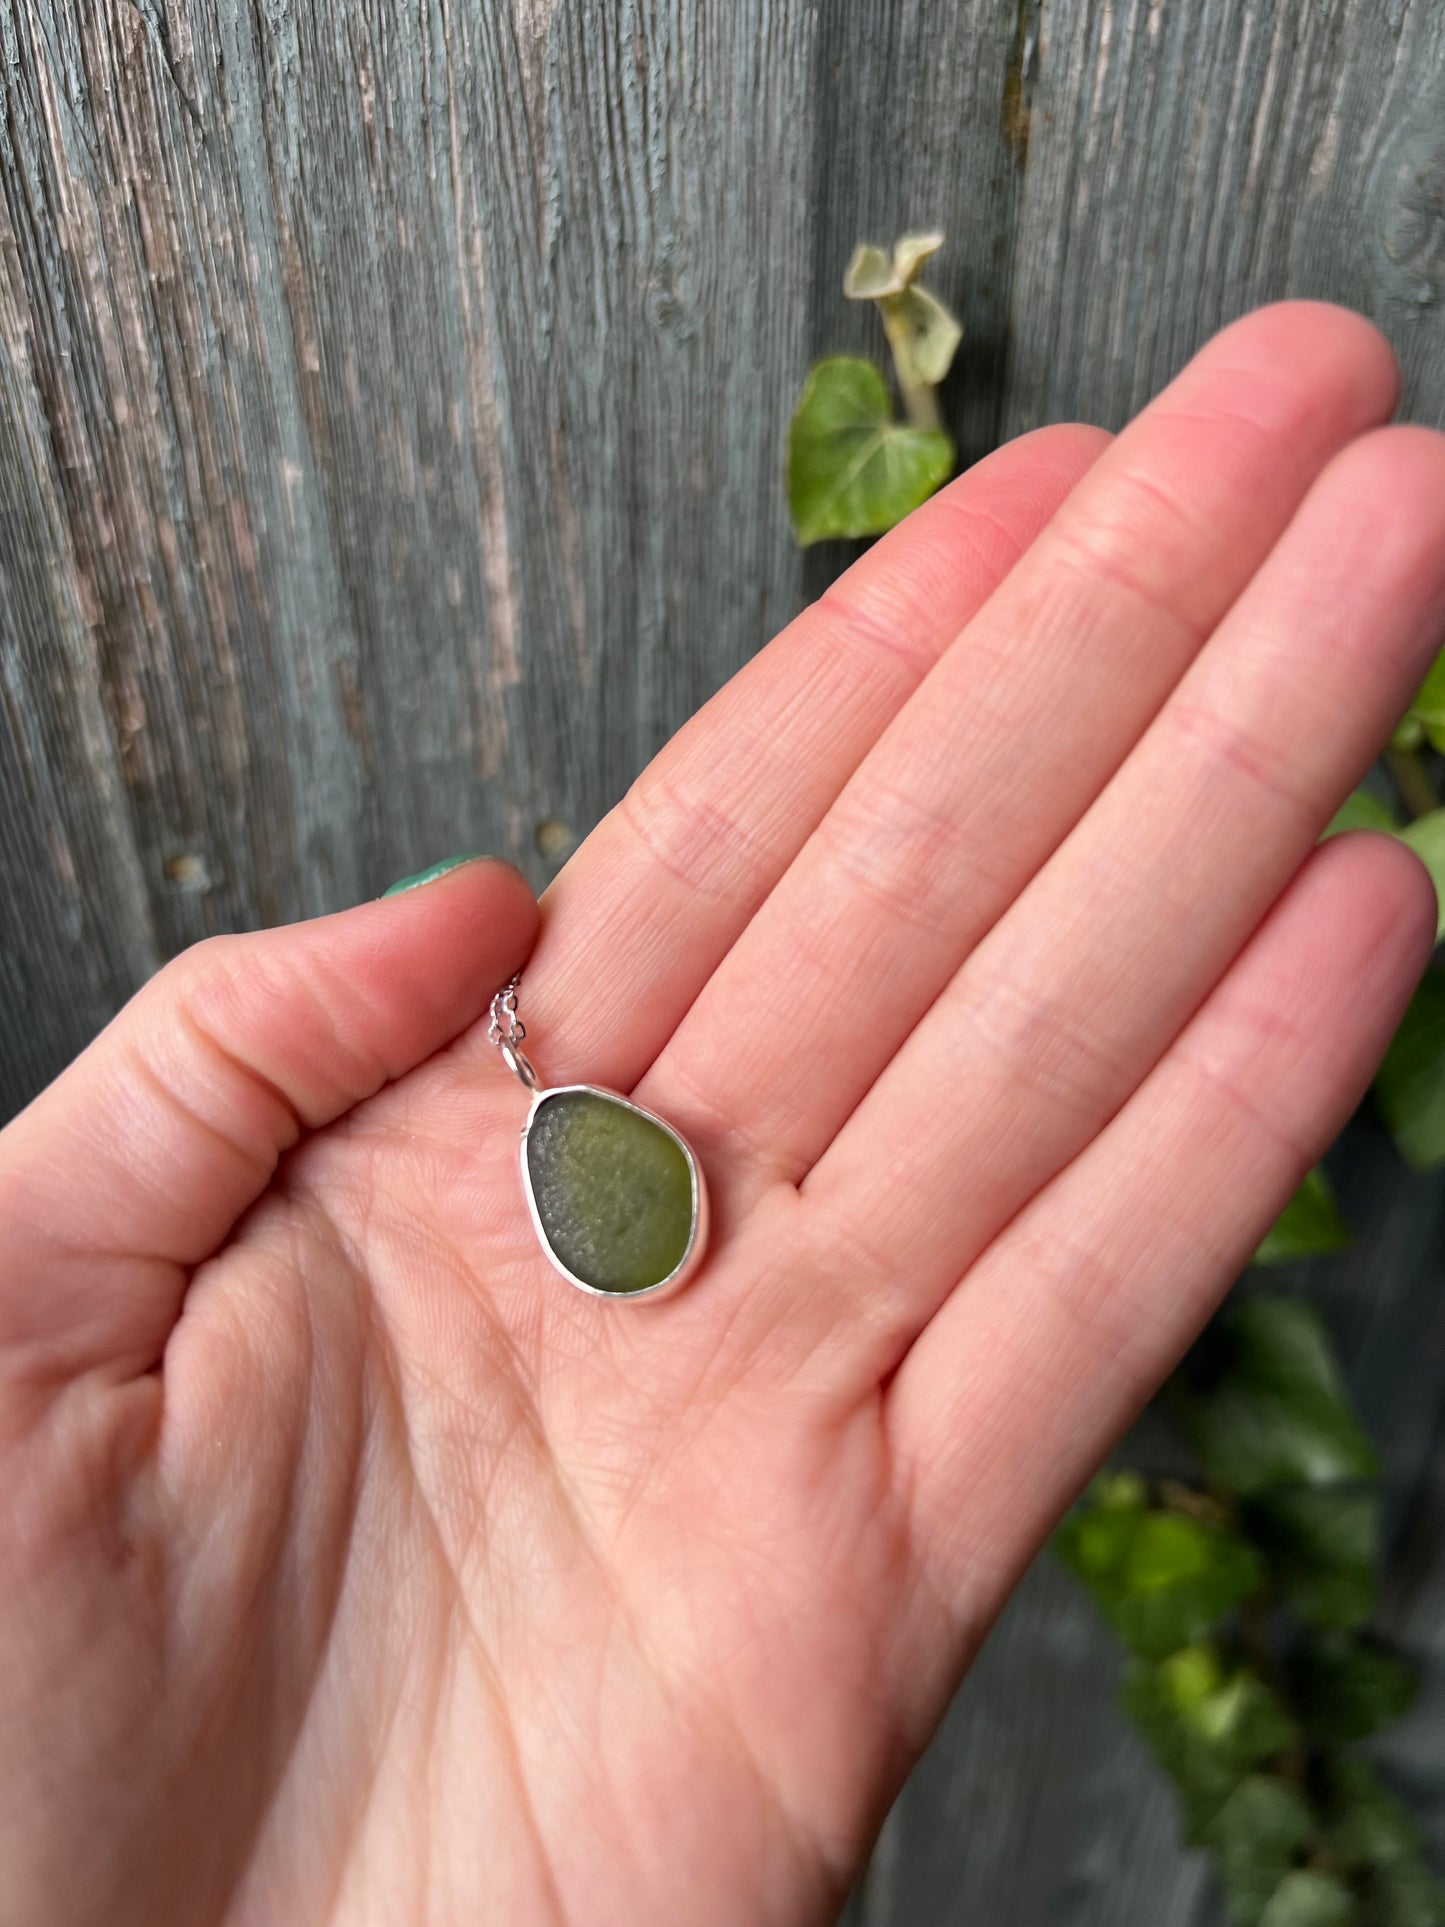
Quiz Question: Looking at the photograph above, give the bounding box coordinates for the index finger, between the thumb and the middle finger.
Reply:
[497,428,1108,1091]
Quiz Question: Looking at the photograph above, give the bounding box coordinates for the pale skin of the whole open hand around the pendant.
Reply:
[0,304,1445,1927]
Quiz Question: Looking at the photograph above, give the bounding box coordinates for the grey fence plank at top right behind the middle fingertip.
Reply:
[1004,0,1445,434]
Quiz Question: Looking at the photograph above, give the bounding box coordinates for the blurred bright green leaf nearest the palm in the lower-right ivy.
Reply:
[1054,1482,1264,1659]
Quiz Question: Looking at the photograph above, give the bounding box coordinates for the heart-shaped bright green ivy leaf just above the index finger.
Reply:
[788,355,954,547]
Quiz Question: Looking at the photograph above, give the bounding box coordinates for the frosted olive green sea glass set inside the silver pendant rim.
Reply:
[526,1091,696,1293]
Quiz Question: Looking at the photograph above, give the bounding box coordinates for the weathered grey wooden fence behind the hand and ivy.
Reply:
[0,0,1445,1927]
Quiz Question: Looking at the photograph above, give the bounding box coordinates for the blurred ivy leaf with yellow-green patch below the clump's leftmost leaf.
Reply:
[1121,1646,1299,1844]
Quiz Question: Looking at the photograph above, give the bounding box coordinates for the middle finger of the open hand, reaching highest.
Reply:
[640,303,1397,1204]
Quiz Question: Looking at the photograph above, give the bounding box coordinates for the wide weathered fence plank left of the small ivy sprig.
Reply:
[0,0,815,1108]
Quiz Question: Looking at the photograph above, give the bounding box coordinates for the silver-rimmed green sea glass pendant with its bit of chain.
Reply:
[489,977,707,1299]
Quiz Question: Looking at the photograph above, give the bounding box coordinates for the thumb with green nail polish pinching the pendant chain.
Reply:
[0,859,538,1376]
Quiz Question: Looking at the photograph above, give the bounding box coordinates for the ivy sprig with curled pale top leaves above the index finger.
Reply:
[788,233,963,547]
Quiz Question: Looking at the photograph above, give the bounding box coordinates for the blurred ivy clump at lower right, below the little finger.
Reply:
[1056,1294,1445,1927]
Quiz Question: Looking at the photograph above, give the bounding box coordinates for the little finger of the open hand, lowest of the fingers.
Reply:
[886,836,1435,1642]
